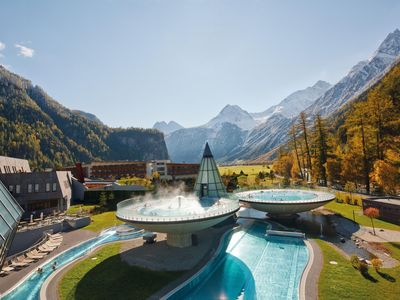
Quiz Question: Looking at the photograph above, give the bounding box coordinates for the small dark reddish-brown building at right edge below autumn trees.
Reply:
[362,196,400,225]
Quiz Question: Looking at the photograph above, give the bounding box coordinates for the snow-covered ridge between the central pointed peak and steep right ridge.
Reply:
[251,80,332,122]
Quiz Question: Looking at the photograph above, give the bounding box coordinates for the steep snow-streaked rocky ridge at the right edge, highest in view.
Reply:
[306,29,400,116]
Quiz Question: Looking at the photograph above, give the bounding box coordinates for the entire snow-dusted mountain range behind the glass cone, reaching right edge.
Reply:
[166,29,400,161]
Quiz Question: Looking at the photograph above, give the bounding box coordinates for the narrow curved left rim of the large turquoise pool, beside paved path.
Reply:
[160,224,243,300]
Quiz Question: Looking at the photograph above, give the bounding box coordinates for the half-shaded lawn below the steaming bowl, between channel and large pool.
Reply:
[58,243,182,300]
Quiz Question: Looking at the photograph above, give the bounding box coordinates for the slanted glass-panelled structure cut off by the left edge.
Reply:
[0,182,23,269]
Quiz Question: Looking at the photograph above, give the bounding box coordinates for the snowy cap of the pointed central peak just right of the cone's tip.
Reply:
[203,104,257,130]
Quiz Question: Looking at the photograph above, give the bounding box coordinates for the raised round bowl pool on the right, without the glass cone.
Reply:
[236,189,335,216]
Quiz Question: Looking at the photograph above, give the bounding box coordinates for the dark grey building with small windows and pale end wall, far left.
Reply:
[0,171,72,218]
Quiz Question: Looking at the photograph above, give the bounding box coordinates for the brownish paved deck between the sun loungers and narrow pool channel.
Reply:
[0,230,97,296]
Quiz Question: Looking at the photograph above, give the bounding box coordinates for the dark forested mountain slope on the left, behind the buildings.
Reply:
[0,66,168,169]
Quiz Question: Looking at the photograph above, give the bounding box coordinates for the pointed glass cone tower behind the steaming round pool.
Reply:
[194,143,227,198]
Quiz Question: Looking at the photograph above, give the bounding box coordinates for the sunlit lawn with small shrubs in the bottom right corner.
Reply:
[316,240,400,300]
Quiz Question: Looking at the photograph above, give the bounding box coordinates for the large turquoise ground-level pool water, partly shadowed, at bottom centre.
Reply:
[169,223,308,300]
